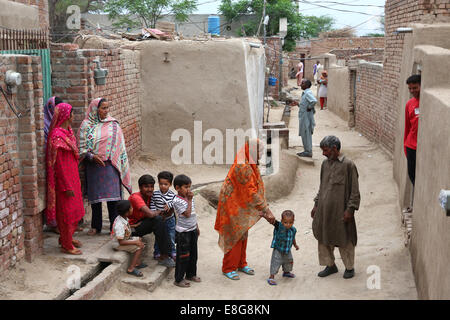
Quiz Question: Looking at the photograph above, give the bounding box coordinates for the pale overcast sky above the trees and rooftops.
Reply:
[195,0,385,36]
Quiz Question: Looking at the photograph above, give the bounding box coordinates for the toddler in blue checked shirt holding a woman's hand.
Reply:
[267,210,299,285]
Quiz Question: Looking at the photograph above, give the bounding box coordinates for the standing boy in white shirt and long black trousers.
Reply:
[172,174,201,288]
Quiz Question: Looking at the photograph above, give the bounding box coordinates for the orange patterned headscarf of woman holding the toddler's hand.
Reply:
[214,140,267,253]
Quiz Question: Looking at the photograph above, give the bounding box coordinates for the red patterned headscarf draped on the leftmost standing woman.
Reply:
[46,103,78,226]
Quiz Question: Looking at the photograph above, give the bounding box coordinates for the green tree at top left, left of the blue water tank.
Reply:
[103,0,197,28]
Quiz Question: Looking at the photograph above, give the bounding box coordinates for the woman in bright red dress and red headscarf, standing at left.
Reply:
[46,103,84,254]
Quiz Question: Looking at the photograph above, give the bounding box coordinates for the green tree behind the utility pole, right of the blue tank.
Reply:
[219,0,334,51]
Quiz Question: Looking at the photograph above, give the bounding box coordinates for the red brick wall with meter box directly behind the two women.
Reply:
[51,44,141,159]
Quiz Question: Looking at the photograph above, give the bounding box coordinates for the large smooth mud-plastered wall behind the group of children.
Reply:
[138,39,265,163]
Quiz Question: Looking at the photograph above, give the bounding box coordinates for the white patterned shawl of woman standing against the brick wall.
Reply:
[78,98,132,194]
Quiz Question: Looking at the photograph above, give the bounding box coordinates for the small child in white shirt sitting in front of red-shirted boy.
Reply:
[112,200,147,277]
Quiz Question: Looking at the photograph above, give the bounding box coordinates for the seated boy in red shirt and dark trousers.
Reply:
[128,174,175,267]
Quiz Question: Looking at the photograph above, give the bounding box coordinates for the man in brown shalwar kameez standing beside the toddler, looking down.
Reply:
[311,136,361,279]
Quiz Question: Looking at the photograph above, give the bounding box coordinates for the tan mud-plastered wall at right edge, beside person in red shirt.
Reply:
[394,24,450,299]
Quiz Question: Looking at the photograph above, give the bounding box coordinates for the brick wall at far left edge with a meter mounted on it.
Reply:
[0,55,43,272]
